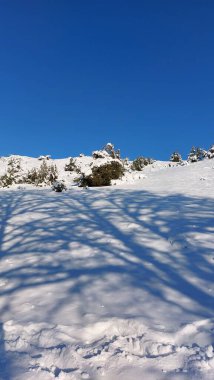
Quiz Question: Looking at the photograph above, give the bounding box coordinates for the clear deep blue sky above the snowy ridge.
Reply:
[0,0,214,159]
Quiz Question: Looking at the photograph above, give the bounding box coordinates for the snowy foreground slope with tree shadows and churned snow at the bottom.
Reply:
[0,158,214,380]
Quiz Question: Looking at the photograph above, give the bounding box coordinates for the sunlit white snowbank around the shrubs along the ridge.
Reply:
[0,150,178,189]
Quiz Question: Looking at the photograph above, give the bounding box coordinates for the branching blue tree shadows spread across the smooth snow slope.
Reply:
[0,189,214,323]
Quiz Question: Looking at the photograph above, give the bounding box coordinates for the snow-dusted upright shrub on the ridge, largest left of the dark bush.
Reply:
[25,161,58,185]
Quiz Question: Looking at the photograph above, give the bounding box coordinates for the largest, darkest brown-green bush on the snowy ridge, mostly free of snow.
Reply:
[79,161,124,187]
